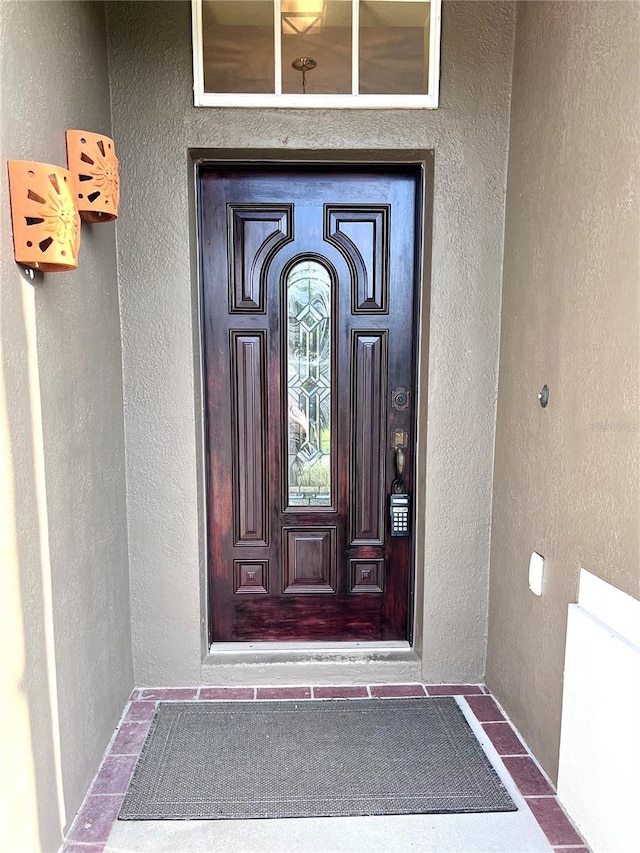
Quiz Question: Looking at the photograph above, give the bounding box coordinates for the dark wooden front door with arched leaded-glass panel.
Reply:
[200,166,418,641]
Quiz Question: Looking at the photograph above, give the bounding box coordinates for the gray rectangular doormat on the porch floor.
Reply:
[120,698,516,820]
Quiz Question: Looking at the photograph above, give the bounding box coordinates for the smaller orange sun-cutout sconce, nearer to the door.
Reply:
[67,130,120,222]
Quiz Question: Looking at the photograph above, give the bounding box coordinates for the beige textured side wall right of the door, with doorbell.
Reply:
[487,2,640,777]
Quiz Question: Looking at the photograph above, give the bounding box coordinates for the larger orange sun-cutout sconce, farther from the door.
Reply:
[8,160,80,272]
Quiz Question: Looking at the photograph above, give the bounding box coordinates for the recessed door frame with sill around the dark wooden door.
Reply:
[188,148,434,684]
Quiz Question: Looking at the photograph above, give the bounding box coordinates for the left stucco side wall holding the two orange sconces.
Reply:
[0,2,133,851]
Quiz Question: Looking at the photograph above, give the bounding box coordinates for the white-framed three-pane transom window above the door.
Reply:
[192,0,441,109]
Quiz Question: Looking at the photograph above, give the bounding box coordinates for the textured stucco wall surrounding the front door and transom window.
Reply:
[107,0,515,685]
